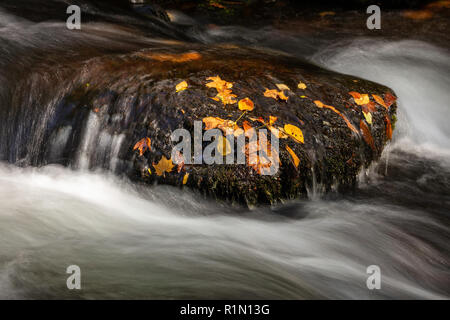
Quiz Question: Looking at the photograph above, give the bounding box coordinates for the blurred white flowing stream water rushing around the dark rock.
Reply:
[0,3,450,299]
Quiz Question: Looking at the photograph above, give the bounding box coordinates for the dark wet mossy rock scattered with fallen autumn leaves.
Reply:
[32,44,396,205]
